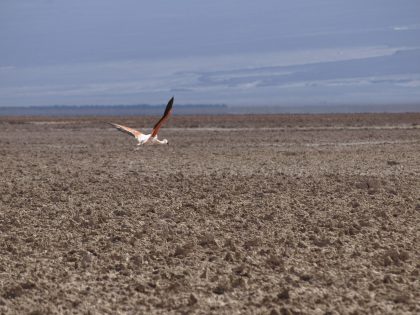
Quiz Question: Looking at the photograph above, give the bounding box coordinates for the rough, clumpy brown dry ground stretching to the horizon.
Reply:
[0,114,420,315]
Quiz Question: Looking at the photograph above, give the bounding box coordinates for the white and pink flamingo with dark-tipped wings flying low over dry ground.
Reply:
[110,97,174,145]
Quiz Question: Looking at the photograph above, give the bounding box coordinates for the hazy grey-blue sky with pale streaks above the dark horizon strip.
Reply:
[0,0,420,106]
